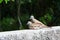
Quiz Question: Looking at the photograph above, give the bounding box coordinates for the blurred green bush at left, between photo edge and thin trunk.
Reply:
[1,17,19,31]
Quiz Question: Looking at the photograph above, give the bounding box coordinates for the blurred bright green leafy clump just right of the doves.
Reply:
[39,9,53,26]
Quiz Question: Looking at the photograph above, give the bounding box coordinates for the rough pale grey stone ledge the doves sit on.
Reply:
[0,26,60,40]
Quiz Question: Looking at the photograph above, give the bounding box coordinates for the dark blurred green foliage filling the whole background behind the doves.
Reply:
[0,0,60,31]
